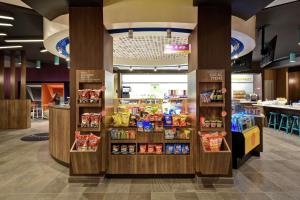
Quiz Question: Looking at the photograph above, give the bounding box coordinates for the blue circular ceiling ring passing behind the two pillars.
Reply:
[56,28,245,57]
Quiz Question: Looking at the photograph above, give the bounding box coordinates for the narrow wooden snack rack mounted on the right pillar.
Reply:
[189,69,231,176]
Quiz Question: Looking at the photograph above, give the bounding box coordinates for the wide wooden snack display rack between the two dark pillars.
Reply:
[107,99,194,174]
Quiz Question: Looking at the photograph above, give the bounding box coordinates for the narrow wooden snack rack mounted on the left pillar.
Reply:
[70,69,112,175]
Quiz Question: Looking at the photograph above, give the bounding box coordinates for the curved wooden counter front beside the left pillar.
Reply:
[49,105,70,165]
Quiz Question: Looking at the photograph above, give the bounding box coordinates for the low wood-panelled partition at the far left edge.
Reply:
[0,100,31,129]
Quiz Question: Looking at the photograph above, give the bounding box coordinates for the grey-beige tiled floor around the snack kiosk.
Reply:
[0,122,300,200]
